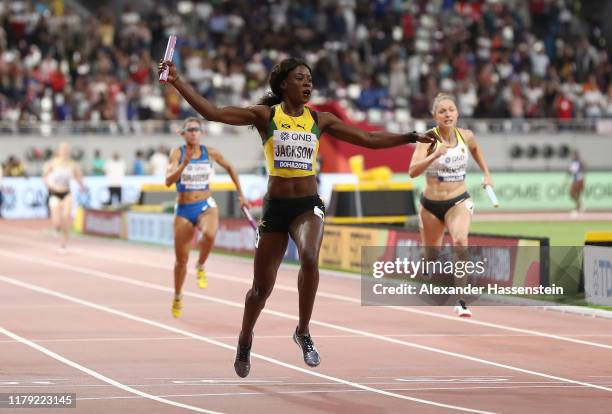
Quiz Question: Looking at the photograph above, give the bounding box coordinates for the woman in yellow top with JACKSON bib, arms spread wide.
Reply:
[159,58,434,377]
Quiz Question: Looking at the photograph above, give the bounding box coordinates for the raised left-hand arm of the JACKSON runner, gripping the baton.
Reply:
[157,61,270,130]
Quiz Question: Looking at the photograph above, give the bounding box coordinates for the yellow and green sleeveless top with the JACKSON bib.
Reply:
[263,105,321,178]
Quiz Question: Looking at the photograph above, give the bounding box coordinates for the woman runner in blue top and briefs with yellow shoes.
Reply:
[166,118,247,318]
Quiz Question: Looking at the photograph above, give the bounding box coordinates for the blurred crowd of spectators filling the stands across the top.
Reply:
[0,0,612,123]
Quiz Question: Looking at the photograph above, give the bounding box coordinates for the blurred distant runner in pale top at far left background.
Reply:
[43,142,85,254]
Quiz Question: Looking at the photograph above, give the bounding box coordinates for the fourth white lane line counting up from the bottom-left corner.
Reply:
[0,231,612,350]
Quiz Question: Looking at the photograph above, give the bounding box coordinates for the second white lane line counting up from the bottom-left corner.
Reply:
[0,275,498,414]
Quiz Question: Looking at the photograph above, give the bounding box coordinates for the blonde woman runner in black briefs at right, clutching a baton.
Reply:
[409,94,493,316]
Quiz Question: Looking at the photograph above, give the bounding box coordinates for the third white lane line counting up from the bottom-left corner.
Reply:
[0,250,612,392]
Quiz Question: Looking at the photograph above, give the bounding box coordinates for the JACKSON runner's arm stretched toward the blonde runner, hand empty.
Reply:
[319,112,435,148]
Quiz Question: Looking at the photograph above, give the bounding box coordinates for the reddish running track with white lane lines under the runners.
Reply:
[0,221,612,414]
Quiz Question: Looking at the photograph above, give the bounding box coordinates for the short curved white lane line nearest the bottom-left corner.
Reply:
[0,326,218,414]
